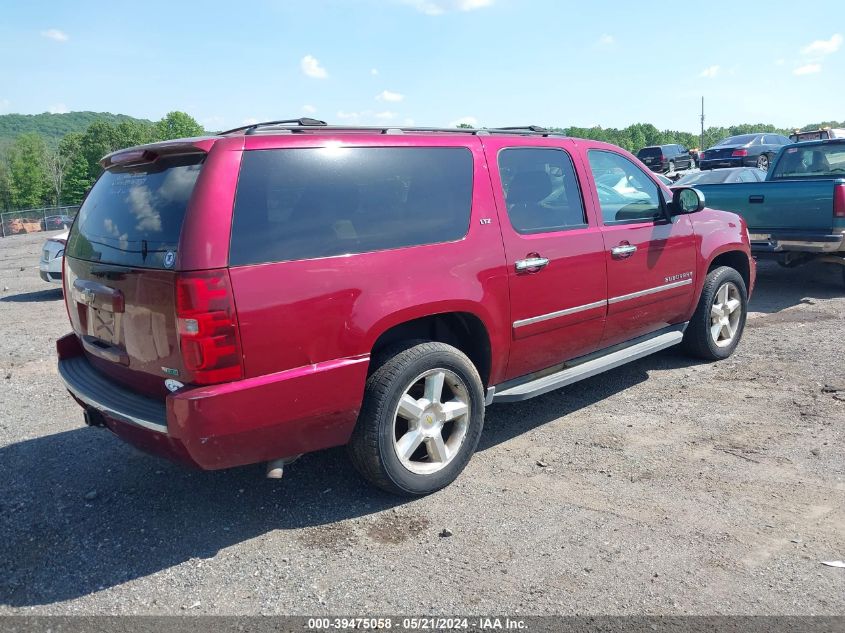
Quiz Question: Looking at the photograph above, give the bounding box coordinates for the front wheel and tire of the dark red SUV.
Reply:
[684,266,748,361]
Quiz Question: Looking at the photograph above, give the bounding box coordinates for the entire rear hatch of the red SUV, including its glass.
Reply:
[64,152,205,397]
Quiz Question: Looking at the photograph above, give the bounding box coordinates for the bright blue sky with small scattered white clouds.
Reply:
[0,0,845,132]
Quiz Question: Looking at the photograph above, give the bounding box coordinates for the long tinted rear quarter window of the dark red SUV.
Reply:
[229,147,473,266]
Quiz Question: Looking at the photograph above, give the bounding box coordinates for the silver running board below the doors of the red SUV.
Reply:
[487,330,684,404]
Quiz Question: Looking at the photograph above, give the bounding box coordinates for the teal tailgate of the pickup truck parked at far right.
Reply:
[693,180,833,233]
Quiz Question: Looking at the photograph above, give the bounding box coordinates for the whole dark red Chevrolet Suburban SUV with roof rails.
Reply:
[58,120,755,494]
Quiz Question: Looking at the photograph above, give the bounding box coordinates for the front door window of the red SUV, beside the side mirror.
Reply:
[588,150,663,224]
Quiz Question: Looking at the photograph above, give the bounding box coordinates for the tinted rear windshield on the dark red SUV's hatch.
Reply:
[67,154,205,268]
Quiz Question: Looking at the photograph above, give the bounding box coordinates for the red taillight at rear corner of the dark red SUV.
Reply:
[176,269,243,385]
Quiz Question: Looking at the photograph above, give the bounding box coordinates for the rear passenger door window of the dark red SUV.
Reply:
[499,147,587,233]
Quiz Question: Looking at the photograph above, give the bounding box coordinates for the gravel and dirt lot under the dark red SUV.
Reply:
[0,234,845,615]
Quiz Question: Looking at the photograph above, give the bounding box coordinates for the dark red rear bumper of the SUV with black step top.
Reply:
[57,334,369,470]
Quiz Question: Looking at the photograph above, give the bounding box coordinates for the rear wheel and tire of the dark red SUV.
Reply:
[349,343,484,496]
